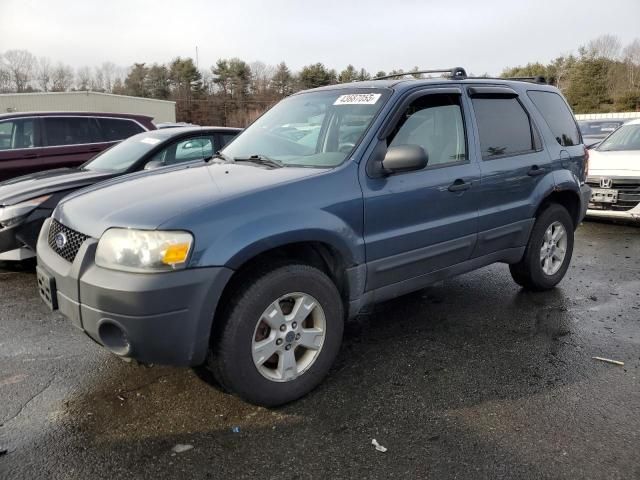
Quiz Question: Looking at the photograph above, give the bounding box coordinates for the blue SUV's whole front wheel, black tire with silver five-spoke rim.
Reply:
[207,264,344,407]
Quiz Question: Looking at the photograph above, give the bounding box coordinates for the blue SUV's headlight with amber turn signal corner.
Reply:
[96,228,193,273]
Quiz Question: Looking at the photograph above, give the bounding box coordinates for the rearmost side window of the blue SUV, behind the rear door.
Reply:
[528,90,580,147]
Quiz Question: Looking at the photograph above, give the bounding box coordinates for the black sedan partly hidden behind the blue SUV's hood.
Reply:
[0,127,241,260]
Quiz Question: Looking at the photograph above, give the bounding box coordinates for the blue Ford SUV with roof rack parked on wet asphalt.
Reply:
[37,68,590,406]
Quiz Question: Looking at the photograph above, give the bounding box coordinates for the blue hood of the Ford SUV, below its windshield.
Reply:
[54,163,324,238]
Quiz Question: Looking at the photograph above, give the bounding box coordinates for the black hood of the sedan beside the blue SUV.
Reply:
[0,168,114,206]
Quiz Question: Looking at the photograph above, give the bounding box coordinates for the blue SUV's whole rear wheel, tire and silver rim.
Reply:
[509,203,574,291]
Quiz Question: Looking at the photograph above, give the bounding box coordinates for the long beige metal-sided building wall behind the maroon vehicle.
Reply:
[0,92,176,123]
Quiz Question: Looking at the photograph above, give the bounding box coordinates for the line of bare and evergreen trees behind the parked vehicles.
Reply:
[0,35,640,126]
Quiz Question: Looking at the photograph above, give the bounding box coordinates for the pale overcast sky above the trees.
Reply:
[0,0,640,75]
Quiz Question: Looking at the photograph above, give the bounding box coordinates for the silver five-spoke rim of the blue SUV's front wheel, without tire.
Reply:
[251,292,326,382]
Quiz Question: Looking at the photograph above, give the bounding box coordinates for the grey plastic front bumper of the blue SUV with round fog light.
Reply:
[37,219,233,366]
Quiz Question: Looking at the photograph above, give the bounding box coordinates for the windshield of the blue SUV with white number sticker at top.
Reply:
[222,88,389,168]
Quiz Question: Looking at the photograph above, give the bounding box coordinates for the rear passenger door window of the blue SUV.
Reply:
[472,98,537,160]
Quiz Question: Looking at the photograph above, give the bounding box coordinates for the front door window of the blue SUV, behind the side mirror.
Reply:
[389,94,467,166]
